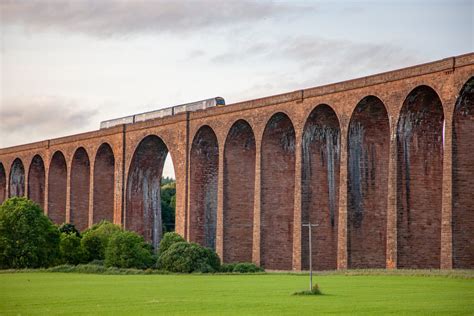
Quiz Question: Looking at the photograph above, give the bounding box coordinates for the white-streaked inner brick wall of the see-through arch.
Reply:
[125,135,168,249]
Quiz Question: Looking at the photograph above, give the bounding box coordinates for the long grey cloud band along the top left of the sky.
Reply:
[0,0,311,37]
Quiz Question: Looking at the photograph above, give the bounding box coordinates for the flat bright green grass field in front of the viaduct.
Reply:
[0,273,474,315]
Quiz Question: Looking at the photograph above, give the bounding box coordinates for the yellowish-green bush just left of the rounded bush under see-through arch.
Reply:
[81,221,123,261]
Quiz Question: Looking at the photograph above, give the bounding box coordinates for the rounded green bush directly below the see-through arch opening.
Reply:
[105,231,155,269]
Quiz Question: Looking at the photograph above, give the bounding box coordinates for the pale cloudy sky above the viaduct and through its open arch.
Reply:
[0,0,474,176]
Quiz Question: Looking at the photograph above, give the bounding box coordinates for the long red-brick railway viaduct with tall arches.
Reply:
[0,53,474,270]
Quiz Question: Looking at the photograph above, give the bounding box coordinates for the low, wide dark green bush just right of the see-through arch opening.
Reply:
[158,242,220,273]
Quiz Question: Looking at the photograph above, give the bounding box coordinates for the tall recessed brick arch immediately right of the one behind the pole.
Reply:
[347,96,390,268]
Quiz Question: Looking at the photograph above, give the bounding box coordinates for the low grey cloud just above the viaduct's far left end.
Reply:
[0,97,98,147]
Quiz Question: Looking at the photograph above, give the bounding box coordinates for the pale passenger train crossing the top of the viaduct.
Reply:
[100,97,225,129]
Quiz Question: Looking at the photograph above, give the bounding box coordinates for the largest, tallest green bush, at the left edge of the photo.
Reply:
[0,197,59,269]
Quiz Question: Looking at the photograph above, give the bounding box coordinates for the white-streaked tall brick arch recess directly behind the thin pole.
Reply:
[301,104,341,270]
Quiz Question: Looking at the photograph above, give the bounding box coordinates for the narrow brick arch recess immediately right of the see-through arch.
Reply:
[189,125,219,249]
